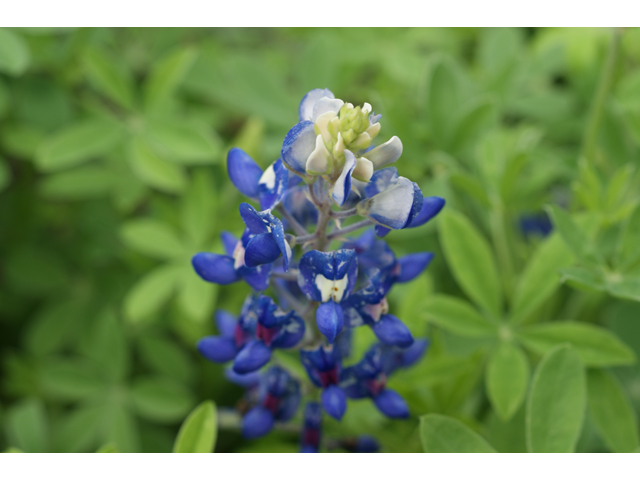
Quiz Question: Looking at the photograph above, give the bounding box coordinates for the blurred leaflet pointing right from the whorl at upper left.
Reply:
[147,118,222,165]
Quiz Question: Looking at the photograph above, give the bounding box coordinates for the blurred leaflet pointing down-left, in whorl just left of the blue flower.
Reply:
[124,265,181,323]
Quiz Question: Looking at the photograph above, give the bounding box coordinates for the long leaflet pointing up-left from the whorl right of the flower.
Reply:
[438,210,502,317]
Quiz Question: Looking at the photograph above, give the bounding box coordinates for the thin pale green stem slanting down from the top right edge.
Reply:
[582,28,623,163]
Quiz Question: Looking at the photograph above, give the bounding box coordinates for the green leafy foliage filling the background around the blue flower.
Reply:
[0,28,640,452]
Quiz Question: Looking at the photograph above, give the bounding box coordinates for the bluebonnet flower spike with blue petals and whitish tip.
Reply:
[192,89,444,452]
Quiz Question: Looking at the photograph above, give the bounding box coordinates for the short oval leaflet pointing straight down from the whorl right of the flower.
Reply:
[486,342,529,421]
